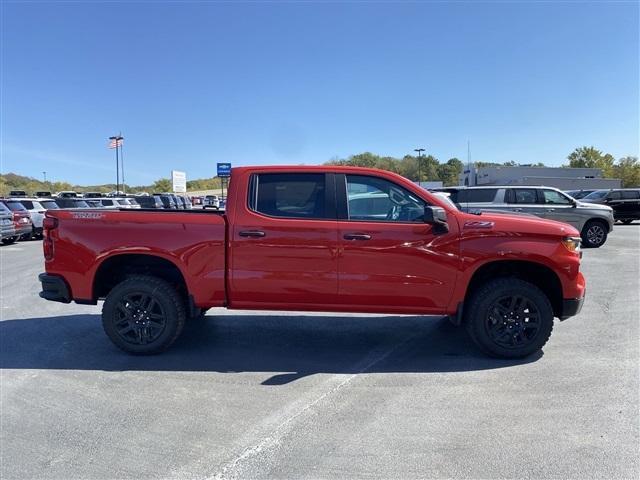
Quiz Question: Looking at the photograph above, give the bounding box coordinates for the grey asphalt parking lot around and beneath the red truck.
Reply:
[0,228,640,479]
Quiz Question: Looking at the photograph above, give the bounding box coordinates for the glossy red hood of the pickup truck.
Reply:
[460,212,580,237]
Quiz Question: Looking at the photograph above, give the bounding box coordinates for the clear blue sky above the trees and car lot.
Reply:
[0,0,639,184]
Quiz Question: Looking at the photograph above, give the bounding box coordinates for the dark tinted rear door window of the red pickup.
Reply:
[255,173,327,218]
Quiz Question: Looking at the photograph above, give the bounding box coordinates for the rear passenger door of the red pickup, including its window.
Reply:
[229,172,338,310]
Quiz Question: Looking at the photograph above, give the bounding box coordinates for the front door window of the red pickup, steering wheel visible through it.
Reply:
[347,175,425,222]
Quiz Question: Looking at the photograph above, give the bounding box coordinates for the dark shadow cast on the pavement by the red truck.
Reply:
[0,314,542,385]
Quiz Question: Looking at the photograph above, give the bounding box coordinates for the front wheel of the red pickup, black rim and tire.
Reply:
[465,278,553,358]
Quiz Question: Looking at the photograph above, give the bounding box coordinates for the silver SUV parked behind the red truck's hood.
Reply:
[441,185,614,248]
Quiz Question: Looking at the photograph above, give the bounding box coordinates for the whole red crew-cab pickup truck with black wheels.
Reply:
[40,166,585,358]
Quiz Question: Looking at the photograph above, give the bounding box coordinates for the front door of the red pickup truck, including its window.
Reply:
[336,174,458,313]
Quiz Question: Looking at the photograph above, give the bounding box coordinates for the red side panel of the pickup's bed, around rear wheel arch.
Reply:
[47,209,226,307]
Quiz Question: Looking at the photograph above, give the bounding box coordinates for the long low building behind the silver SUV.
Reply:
[458,166,622,190]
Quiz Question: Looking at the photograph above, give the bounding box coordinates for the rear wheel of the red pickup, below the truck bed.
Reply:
[102,275,186,355]
